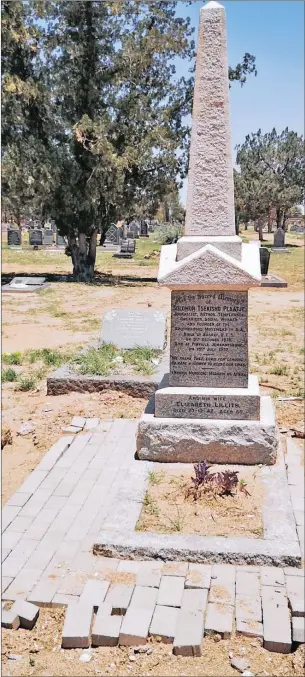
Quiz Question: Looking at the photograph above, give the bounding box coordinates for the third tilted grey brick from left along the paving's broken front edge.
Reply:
[119,605,153,646]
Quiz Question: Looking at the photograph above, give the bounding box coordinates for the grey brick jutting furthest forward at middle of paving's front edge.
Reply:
[173,609,204,656]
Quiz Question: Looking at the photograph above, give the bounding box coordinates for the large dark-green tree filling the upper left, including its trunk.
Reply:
[3,0,255,281]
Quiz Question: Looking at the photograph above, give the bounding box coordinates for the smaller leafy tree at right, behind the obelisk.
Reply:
[235,128,305,238]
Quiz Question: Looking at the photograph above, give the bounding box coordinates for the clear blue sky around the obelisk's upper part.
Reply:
[177,0,304,204]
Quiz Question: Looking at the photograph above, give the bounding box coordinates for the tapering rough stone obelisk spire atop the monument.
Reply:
[185,0,235,236]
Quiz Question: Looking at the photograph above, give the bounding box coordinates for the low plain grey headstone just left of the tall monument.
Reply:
[101,310,166,350]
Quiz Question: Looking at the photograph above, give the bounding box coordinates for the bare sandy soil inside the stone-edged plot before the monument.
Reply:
[137,465,263,538]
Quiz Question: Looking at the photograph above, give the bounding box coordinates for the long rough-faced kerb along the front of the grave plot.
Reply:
[93,531,301,567]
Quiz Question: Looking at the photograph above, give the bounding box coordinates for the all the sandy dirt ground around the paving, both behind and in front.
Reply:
[2,231,304,677]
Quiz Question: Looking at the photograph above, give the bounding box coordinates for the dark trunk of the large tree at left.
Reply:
[68,229,97,282]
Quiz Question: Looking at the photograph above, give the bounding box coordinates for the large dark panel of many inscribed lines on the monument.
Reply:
[169,291,248,388]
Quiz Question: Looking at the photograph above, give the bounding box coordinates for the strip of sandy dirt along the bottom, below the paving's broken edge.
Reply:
[2,609,304,677]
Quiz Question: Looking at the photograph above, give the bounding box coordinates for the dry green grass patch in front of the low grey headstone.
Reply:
[71,343,159,376]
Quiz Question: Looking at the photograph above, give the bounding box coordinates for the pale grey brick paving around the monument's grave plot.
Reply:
[2,419,305,656]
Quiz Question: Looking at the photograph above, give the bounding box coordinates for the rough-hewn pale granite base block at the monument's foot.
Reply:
[137,395,279,465]
